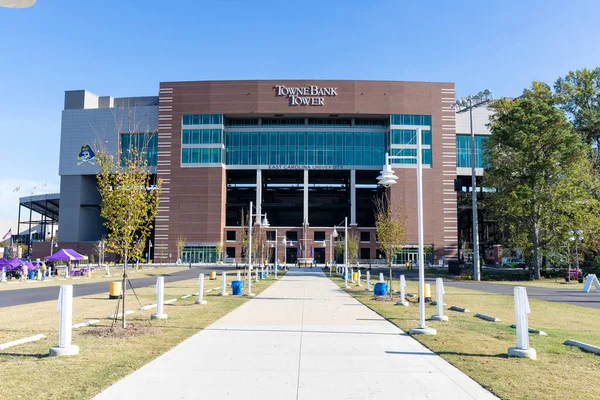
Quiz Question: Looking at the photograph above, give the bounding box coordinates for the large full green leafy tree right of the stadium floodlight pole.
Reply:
[484,82,597,279]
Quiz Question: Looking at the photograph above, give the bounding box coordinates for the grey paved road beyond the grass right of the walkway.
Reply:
[371,268,600,308]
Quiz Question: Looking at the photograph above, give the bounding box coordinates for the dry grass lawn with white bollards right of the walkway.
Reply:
[333,277,600,400]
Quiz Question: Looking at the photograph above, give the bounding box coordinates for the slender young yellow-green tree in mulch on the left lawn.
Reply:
[96,148,162,328]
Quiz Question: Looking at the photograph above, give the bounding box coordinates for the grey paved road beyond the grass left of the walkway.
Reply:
[0,266,232,308]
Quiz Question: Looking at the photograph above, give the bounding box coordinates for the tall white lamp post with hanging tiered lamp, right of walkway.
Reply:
[377,128,437,335]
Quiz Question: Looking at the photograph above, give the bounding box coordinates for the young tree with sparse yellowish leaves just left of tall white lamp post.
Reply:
[374,192,407,297]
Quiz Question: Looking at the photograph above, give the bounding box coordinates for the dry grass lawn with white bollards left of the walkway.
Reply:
[0,271,285,399]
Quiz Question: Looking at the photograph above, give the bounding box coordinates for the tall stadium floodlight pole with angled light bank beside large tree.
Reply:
[455,89,493,281]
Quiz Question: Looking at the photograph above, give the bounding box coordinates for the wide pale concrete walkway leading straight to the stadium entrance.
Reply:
[97,269,495,400]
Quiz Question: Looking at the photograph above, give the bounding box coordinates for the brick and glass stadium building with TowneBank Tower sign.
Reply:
[48,80,487,264]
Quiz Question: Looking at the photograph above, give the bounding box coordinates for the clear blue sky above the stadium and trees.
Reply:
[0,0,600,219]
